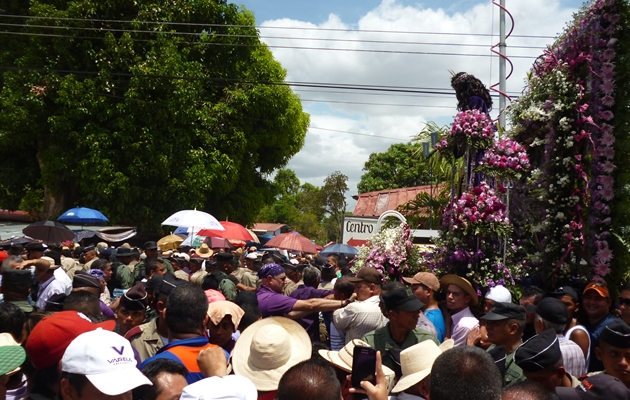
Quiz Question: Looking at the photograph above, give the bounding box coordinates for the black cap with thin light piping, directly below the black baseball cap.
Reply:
[514,329,562,372]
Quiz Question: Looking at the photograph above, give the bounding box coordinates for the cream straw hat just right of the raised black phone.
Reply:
[392,339,455,393]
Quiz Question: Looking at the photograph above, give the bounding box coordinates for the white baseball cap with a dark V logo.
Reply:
[61,328,152,396]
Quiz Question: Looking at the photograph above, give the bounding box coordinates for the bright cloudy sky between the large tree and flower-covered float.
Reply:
[260,0,575,206]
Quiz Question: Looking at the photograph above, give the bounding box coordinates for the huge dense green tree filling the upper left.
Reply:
[0,0,309,228]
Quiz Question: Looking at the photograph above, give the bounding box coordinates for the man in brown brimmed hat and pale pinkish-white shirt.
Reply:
[440,275,479,346]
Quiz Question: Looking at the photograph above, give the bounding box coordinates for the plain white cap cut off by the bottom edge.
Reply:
[179,375,258,400]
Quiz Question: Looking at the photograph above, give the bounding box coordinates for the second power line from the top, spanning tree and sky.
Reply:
[0,23,541,50]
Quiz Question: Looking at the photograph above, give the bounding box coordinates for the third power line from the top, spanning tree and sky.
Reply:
[0,31,538,60]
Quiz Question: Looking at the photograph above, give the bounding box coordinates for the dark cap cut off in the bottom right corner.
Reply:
[556,374,630,400]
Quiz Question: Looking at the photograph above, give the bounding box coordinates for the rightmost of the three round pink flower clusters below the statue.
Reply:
[478,138,530,177]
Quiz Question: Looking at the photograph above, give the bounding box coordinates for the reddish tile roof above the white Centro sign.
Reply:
[352,185,441,217]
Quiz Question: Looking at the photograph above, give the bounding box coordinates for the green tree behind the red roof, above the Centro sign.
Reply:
[357,142,429,193]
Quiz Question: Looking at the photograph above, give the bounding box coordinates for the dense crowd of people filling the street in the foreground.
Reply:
[0,238,630,400]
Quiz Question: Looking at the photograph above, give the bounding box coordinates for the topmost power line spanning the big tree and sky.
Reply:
[0,14,556,39]
